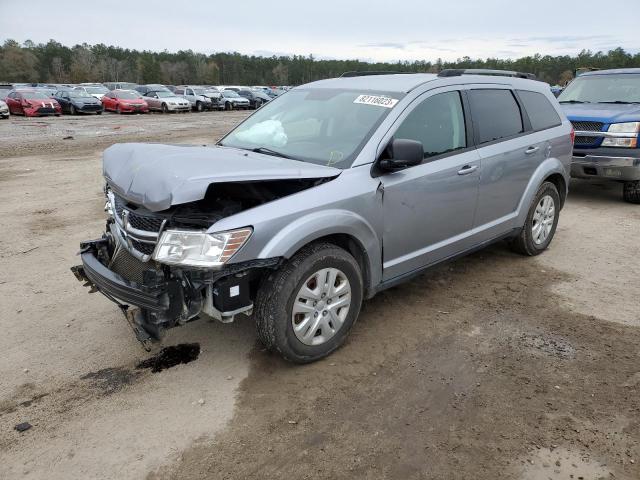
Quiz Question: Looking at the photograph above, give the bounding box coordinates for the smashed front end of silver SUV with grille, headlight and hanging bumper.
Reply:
[71,188,281,350]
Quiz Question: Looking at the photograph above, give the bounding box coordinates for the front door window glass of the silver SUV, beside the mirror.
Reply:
[394,92,467,158]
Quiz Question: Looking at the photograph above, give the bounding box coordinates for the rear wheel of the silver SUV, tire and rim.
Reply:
[511,182,560,256]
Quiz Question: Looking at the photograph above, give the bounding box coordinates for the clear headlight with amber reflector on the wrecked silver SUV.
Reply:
[153,228,253,267]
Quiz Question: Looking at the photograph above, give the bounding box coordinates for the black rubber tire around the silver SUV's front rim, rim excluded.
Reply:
[255,243,363,363]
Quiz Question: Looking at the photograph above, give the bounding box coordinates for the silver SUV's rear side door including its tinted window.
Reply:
[468,85,545,234]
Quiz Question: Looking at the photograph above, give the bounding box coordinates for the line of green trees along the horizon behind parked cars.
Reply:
[0,40,640,85]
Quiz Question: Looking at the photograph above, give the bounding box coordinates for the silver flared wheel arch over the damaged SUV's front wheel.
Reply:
[258,209,382,287]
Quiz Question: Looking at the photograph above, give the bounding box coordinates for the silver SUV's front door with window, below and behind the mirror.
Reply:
[380,88,480,281]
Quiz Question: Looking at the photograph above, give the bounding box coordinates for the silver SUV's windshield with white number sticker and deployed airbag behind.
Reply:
[220,89,403,168]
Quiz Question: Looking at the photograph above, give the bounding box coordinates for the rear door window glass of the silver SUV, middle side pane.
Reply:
[469,89,524,143]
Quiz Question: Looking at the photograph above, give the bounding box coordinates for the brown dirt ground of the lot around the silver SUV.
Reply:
[0,112,640,480]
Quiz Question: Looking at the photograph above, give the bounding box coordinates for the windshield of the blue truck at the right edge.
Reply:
[558,73,640,103]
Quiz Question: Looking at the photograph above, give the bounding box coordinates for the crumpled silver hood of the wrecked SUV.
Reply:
[102,143,341,212]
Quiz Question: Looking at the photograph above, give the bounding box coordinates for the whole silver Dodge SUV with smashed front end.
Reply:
[72,70,573,363]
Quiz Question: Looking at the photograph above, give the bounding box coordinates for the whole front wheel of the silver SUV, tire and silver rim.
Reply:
[255,243,363,363]
